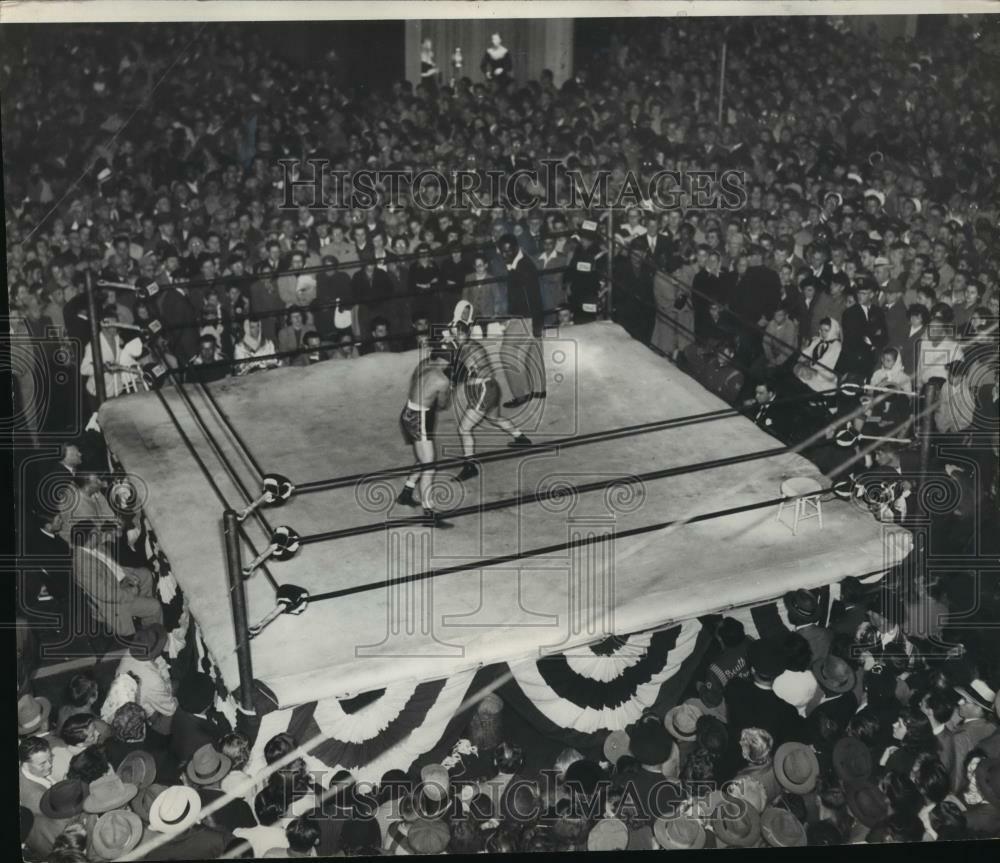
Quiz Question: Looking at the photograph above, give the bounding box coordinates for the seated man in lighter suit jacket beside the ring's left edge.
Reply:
[73,521,163,637]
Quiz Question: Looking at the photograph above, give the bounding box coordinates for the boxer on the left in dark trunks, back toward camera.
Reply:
[396,345,453,527]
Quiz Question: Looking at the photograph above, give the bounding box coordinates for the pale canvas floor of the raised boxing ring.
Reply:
[100,323,909,709]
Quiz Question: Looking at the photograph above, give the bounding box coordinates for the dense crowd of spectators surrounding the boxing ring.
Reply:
[9,11,1000,861]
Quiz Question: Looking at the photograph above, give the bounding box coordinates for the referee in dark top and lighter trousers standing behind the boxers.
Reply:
[497,234,545,408]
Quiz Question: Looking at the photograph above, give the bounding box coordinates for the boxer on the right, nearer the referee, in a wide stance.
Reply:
[451,321,531,481]
